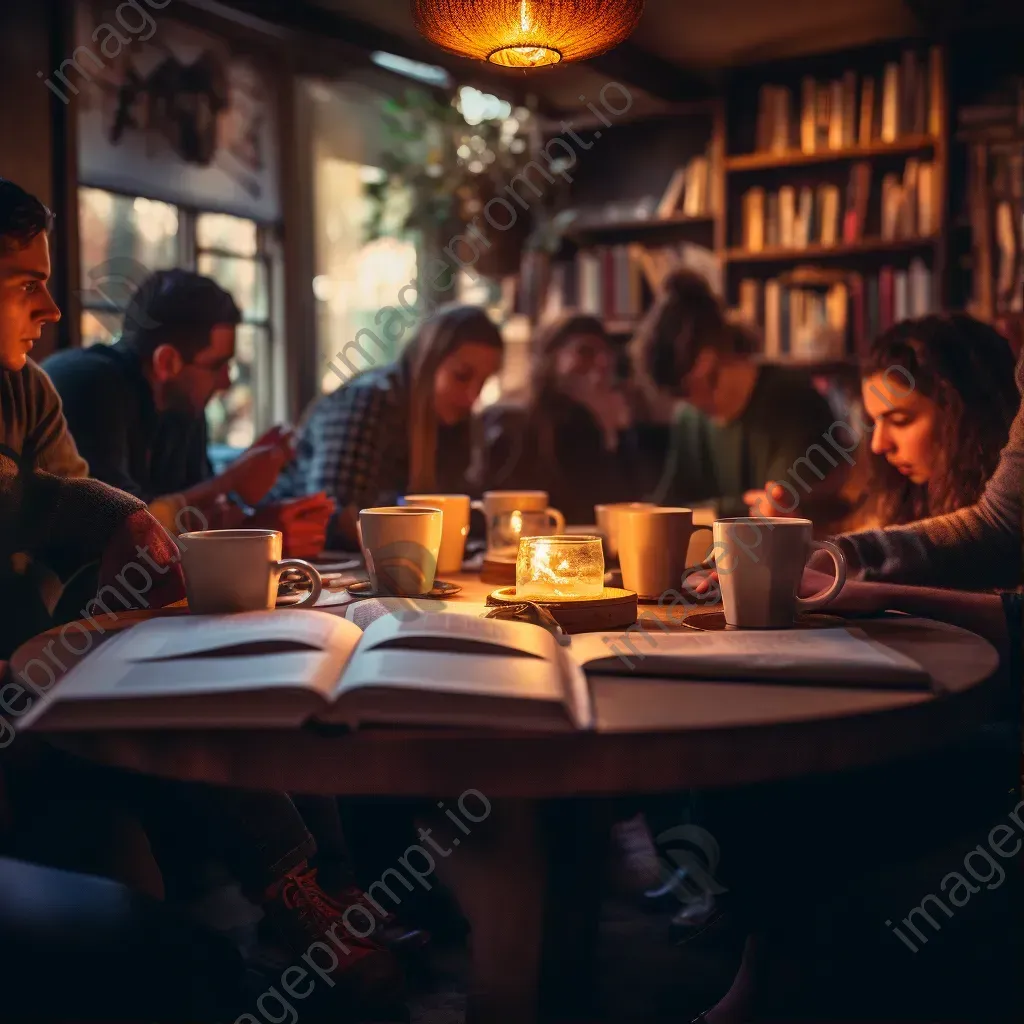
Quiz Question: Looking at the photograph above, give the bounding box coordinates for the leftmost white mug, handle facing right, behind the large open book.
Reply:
[177,529,324,615]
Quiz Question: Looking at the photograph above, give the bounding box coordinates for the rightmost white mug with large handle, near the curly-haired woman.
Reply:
[713,516,846,629]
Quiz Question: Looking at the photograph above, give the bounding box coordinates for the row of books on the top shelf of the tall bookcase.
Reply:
[755,47,942,154]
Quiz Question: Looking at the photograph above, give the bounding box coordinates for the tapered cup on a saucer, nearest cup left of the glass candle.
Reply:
[358,505,442,597]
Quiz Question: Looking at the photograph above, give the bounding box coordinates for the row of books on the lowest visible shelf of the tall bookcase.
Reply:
[735,258,936,359]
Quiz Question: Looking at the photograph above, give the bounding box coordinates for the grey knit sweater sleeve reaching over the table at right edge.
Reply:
[837,354,1024,590]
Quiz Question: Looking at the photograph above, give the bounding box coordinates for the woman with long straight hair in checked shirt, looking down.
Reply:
[274,305,503,549]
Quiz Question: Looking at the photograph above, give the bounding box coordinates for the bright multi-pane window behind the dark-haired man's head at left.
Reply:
[79,187,272,447]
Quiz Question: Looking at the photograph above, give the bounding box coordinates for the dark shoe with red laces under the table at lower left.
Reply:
[263,868,403,1019]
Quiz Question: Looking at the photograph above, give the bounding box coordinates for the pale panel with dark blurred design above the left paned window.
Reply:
[68,0,280,222]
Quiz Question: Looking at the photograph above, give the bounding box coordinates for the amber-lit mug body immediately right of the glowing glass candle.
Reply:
[615,507,693,600]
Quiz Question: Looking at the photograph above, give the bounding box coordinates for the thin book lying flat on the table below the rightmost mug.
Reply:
[569,627,931,689]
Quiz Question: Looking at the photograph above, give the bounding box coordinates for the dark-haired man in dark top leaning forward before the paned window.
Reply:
[44,269,333,558]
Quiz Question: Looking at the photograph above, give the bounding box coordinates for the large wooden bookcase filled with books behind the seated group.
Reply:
[522,39,949,373]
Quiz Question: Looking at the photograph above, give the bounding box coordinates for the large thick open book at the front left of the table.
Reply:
[19,609,592,731]
